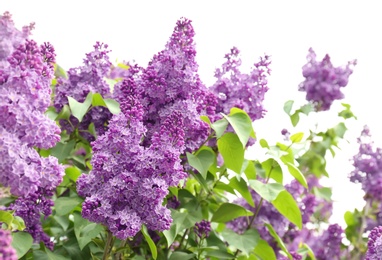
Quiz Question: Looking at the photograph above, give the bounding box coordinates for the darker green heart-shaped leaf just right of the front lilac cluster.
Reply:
[187,147,216,179]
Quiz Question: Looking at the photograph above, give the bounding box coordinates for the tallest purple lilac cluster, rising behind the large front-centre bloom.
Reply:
[114,18,217,150]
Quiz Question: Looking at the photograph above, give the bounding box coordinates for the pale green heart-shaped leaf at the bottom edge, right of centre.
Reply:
[222,229,260,255]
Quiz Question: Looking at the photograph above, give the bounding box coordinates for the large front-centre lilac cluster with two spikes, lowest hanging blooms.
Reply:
[77,80,187,239]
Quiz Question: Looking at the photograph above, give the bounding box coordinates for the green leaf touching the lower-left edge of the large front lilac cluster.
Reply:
[73,212,104,250]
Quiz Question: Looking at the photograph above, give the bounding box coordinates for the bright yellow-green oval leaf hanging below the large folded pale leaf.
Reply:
[217,133,244,174]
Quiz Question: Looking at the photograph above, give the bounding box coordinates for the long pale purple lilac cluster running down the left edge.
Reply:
[0,13,63,249]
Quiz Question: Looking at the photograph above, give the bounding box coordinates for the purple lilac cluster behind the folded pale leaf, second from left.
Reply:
[54,42,112,141]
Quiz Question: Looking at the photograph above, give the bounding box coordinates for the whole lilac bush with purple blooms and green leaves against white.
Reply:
[0,10,374,260]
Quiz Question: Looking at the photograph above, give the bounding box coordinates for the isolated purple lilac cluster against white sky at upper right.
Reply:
[299,48,356,111]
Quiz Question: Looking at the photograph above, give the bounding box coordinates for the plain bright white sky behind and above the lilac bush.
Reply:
[0,0,382,228]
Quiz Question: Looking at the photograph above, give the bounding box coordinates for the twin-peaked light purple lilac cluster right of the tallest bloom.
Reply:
[210,47,270,121]
